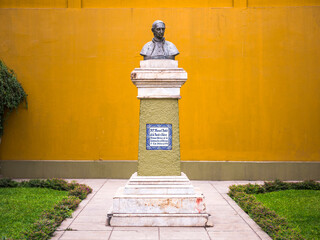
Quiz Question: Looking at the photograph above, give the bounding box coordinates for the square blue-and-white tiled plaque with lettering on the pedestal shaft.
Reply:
[146,124,172,150]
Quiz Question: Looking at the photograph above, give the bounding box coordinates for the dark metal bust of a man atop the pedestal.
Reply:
[140,20,179,60]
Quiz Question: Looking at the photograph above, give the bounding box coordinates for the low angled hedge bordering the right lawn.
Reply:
[228,180,320,240]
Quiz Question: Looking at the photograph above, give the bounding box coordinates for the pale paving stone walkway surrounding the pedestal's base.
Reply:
[52,179,271,240]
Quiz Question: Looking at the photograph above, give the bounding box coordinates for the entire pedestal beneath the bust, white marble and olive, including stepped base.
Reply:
[107,60,209,226]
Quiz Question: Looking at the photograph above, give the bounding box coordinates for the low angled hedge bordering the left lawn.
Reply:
[0,178,92,240]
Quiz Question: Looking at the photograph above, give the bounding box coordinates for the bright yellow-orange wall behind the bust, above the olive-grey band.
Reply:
[0,0,320,161]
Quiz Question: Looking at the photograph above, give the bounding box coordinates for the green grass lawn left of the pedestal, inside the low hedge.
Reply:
[0,188,68,239]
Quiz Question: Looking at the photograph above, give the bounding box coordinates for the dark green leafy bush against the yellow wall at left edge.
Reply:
[0,60,27,137]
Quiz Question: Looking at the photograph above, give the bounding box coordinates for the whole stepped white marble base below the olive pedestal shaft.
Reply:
[107,173,209,227]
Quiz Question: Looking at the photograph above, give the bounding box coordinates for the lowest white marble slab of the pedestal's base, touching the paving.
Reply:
[107,213,209,227]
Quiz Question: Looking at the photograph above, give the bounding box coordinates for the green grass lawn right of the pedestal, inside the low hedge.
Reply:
[254,190,320,240]
